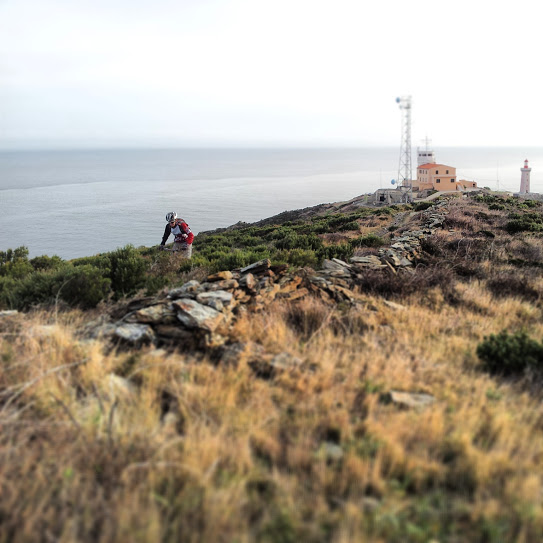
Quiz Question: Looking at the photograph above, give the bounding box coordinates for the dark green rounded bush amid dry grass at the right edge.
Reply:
[477,330,543,375]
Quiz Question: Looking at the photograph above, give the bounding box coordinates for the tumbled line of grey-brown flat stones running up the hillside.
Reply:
[86,204,446,376]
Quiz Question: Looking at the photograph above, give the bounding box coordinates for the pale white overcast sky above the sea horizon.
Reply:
[0,0,543,148]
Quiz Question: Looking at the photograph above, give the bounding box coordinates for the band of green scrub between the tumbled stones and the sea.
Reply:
[0,207,400,310]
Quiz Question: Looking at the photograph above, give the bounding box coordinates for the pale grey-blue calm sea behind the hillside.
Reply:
[0,147,543,259]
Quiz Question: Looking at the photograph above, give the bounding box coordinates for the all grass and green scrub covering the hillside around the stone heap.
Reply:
[0,195,543,543]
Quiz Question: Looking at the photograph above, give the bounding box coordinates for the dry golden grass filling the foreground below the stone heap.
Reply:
[0,274,543,542]
